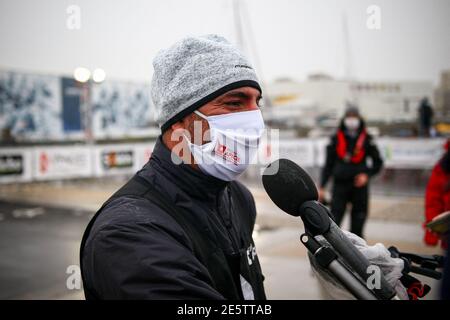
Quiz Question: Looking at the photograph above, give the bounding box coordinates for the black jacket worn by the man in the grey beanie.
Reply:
[81,139,265,299]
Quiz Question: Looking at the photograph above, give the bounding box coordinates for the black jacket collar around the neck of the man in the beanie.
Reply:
[149,136,229,201]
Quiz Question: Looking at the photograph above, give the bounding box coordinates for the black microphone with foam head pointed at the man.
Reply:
[262,159,396,300]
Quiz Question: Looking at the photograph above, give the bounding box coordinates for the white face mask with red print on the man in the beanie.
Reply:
[186,110,264,181]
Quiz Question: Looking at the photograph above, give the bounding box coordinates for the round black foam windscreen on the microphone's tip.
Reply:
[262,159,318,216]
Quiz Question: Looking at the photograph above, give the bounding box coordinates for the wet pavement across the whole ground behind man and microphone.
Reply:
[0,178,440,299]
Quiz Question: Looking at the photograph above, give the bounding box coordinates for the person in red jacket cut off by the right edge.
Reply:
[424,139,450,248]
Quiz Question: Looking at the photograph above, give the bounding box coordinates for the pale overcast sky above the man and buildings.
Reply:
[0,0,450,84]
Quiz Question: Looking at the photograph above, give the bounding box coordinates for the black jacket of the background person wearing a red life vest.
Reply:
[320,120,383,187]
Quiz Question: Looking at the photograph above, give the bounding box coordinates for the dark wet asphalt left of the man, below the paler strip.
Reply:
[0,201,92,299]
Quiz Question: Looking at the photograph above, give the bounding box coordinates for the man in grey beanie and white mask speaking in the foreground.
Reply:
[80,35,266,300]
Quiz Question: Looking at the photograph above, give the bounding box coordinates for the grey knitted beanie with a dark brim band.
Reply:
[151,35,261,132]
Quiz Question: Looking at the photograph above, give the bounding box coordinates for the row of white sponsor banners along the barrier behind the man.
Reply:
[0,138,446,183]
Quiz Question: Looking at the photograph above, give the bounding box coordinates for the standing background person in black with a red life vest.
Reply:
[319,106,383,237]
